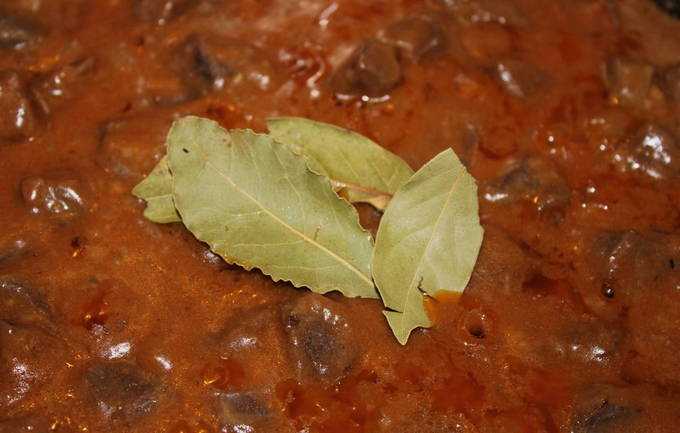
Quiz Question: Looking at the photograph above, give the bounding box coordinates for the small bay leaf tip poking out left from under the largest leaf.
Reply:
[132,156,181,223]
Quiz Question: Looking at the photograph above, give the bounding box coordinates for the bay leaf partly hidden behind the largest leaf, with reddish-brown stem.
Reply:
[267,117,413,210]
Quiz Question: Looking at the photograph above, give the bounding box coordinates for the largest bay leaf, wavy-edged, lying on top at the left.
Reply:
[168,116,377,298]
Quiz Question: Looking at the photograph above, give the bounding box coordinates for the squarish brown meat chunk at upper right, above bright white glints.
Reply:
[606,57,655,109]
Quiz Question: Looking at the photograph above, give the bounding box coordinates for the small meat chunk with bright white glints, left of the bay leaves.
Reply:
[21,176,83,218]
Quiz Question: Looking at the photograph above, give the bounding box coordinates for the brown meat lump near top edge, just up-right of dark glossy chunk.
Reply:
[385,15,448,62]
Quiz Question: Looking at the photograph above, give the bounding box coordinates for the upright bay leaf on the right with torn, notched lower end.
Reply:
[372,149,484,344]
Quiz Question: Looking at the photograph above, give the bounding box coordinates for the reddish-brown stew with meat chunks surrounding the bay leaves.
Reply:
[0,0,680,433]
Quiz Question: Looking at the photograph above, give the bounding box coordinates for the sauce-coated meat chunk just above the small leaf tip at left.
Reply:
[96,116,172,175]
